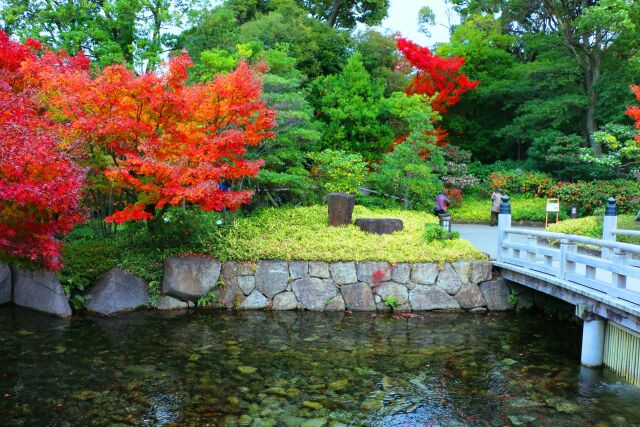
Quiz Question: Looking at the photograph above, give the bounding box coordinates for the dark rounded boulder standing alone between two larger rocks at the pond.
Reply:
[85,268,149,316]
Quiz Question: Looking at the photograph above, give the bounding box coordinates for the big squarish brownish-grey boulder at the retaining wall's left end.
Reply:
[162,256,221,301]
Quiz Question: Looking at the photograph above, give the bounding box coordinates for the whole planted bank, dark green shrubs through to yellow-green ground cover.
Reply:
[60,206,483,304]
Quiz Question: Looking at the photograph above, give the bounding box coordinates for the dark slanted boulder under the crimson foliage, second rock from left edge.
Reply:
[11,268,71,317]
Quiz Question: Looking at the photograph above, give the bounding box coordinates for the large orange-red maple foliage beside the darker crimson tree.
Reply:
[28,54,275,223]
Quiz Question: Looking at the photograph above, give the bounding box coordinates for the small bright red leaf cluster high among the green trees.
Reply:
[398,37,479,113]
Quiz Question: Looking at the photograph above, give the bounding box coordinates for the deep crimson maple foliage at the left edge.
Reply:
[0,31,84,270]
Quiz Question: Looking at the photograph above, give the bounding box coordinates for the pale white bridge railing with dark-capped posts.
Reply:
[497,196,640,305]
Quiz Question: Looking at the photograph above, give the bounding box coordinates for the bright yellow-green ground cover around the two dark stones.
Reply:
[206,206,483,263]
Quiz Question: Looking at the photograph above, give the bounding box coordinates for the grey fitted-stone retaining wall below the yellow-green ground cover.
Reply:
[161,257,504,311]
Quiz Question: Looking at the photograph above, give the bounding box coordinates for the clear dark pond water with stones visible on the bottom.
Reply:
[0,307,640,427]
